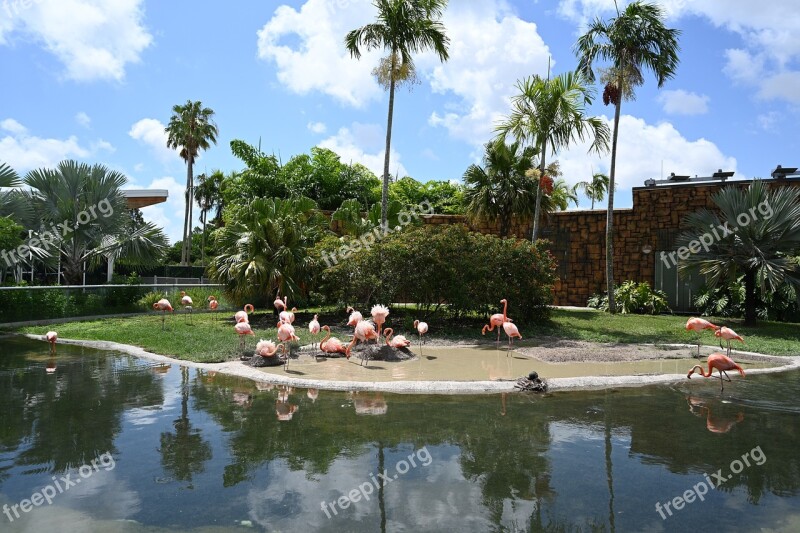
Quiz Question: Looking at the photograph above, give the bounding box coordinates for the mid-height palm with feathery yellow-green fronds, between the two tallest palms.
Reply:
[497,72,609,241]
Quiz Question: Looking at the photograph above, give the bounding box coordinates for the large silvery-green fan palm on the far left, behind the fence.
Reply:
[23,161,167,284]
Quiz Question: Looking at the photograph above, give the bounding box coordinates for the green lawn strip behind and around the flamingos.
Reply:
[10,309,800,363]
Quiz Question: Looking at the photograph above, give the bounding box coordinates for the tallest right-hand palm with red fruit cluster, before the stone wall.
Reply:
[575,1,680,313]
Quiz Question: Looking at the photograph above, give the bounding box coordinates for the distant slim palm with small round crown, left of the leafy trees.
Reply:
[165,100,219,265]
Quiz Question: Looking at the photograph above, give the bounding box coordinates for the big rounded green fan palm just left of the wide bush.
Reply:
[208,198,327,304]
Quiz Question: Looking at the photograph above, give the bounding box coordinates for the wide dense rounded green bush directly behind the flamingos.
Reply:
[311,225,555,321]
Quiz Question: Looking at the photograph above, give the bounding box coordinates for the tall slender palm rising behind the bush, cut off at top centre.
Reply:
[345,0,450,225]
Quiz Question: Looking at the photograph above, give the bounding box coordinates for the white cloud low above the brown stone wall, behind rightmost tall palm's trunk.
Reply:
[557,115,741,189]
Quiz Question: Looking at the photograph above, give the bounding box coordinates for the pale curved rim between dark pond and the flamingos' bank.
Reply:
[18,334,800,394]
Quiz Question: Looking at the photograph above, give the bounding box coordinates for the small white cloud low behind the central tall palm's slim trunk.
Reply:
[319,123,408,178]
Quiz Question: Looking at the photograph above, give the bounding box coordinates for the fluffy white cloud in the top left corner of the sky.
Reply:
[0,0,152,81]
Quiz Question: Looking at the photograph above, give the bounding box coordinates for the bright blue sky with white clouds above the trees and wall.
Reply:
[0,0,800,241]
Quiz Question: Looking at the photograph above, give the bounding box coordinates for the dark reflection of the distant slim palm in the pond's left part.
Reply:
[159,366,211,487]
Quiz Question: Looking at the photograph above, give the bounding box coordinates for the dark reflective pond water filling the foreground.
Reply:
[0,338,800,532]
